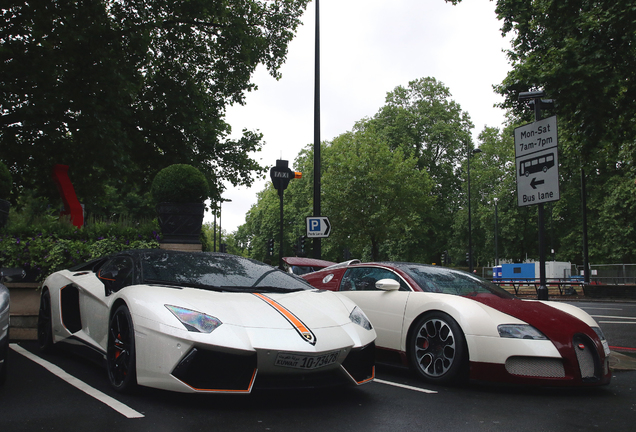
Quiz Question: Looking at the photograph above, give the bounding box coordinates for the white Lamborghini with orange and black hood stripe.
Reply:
[38,250,376,393]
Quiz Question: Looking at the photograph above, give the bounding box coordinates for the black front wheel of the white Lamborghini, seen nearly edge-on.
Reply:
[106,305,137,392]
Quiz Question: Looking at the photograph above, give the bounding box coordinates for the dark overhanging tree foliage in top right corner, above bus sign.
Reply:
[496,0,636,163]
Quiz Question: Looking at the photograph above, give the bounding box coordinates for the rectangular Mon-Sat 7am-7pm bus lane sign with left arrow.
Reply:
[515,116,560,207]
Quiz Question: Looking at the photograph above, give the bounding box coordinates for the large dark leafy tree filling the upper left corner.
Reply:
[0,0,308,214]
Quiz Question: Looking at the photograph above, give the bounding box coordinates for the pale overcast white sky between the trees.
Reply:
[204,0,510,232]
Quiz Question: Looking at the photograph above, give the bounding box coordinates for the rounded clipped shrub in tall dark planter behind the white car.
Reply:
[150,164,210,244]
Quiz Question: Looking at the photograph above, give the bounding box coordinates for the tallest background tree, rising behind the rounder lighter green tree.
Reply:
[372,77,473,261]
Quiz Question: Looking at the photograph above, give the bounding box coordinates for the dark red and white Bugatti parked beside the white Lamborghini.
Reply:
[302,261,611,386]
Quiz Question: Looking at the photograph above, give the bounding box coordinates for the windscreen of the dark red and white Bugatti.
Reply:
[399,264,514,298]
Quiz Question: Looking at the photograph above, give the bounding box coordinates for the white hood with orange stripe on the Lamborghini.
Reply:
[126,286,355,329]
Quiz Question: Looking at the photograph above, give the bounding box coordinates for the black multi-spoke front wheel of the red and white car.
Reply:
[409,312,468,384]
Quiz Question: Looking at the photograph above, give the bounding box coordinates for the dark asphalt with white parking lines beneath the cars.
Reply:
[0,303,636,432]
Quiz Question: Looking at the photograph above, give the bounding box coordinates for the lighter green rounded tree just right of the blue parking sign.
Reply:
[323,122,435,261]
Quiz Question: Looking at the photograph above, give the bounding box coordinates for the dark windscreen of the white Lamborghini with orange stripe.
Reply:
[142,252,313,292]
